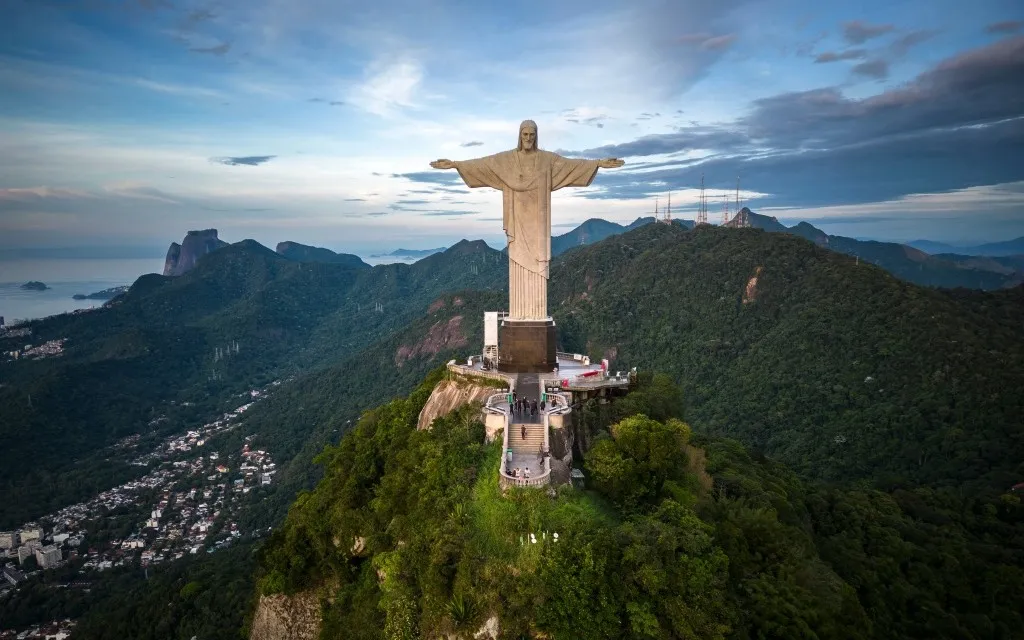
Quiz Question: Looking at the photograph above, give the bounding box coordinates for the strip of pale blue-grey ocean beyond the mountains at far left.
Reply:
[0,258,164,325]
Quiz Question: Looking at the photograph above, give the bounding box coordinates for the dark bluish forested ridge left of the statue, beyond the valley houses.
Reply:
[0,241,508,529]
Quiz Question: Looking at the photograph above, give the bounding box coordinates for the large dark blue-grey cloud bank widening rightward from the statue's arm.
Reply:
[565,37,1024,206]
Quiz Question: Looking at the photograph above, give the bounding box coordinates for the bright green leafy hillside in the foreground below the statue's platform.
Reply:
[249,375,1024,639]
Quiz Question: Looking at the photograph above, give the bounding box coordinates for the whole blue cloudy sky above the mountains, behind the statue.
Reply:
[0,0,1024,257]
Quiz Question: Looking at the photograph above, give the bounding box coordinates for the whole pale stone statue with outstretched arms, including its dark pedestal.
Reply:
[430,120,624,373]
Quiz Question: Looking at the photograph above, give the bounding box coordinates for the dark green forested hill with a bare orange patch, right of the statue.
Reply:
[549,224,1024,490]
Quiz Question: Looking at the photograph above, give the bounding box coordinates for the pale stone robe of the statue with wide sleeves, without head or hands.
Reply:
[455,150,598,319]
